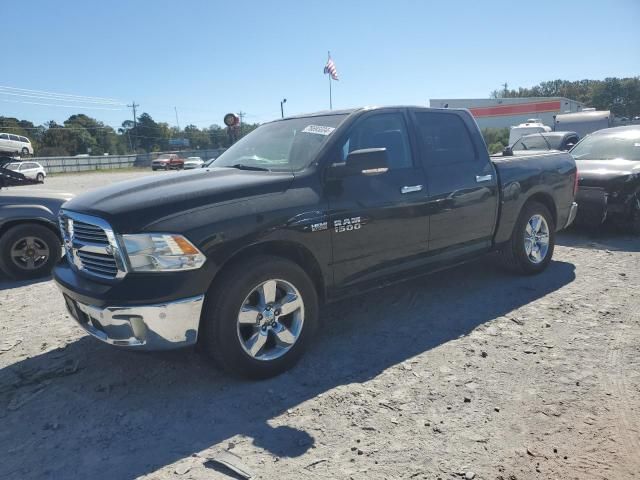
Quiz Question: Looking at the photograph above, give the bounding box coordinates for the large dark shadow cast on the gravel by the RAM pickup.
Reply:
[0,260,575,479]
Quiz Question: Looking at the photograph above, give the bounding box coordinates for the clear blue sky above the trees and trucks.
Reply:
[0,0,640,127]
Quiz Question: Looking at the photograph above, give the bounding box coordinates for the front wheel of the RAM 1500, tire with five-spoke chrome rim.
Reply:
[200,255,318,379]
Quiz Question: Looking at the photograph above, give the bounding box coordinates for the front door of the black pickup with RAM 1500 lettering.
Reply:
[326,109,429,288]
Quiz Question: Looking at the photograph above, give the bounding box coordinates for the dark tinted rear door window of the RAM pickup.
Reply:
[416,112,476,165]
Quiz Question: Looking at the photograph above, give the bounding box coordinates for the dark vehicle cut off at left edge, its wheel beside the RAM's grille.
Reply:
[0,187,72,280]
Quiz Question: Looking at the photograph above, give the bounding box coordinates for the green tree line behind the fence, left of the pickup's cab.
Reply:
[0,113,258,157]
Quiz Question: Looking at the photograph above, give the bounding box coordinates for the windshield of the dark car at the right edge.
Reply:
[571,129,640,160]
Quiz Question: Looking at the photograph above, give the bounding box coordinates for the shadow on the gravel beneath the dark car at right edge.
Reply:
[556,224,640,252]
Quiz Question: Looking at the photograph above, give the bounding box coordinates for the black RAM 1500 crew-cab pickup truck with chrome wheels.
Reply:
[54,107,576,377]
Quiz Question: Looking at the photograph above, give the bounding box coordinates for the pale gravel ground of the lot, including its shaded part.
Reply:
[0,172,640,480]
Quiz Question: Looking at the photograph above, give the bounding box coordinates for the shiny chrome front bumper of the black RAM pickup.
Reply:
[64,295,204,350]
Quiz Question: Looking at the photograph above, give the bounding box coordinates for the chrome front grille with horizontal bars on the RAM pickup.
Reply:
[60,210,126,279]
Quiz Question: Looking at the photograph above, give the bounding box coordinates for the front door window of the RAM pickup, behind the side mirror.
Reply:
[342,113,413,170]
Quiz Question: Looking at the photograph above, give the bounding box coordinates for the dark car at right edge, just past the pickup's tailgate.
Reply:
[571,125,640,234]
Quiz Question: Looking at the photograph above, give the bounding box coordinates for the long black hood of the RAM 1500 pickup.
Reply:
[64,168,294,233]
